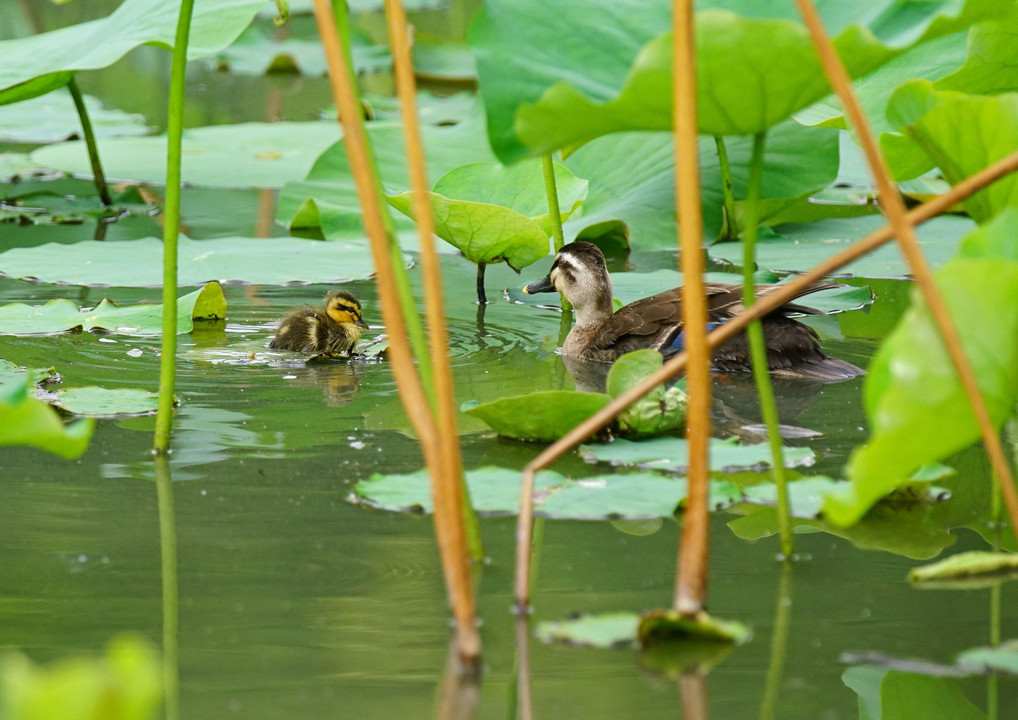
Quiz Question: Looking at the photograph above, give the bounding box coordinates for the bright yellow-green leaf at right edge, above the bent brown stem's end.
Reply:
[882,80,1018,217]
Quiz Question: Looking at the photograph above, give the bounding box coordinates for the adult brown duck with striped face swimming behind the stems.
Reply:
[523,240,864,382]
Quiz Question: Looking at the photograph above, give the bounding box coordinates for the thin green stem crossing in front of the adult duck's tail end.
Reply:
[742,132,794,560]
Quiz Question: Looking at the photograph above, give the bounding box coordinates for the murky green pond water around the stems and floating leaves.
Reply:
[0,1,1018,720]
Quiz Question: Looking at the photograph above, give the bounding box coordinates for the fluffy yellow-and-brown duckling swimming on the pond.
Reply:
[269,290,367,355]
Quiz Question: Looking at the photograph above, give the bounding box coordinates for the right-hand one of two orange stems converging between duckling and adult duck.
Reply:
[385,0,484,669]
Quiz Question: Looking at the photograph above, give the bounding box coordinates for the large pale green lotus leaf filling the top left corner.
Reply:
[0,0,265,104]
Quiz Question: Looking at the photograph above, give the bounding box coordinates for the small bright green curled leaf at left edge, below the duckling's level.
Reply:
[0,373,96,458]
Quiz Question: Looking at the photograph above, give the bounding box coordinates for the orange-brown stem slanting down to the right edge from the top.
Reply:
[795,0,1018,538]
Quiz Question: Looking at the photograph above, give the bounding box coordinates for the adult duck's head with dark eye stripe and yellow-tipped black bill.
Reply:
[523,240,612,322]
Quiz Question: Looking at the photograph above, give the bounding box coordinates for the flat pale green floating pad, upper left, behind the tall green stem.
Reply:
[32,122,340,187]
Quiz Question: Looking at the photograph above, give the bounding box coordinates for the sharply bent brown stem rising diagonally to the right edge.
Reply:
[515,152,1018,608]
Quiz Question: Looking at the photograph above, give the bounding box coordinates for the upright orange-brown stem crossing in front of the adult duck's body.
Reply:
[672,0,711,617]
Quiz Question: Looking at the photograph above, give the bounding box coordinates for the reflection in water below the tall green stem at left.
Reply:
[155,455,180,720]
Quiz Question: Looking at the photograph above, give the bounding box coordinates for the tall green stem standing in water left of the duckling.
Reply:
[155,0,194,453]
